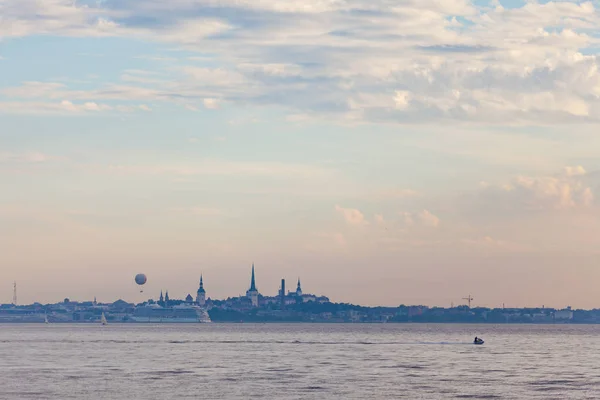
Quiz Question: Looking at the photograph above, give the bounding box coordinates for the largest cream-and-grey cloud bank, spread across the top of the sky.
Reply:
[0,0,600,125]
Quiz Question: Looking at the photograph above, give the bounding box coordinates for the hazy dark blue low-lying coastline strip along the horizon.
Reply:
[0,299,600,325]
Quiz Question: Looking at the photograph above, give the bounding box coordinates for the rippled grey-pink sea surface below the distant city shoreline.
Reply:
[0,324,600,400]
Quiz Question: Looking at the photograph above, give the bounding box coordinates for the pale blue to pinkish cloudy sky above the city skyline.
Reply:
[0,0,600,308]
